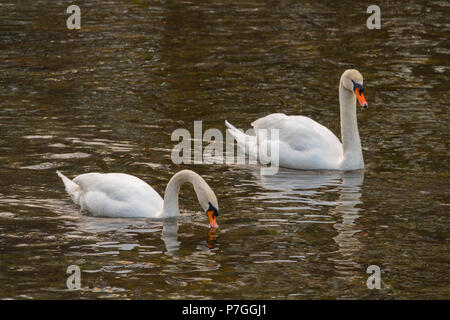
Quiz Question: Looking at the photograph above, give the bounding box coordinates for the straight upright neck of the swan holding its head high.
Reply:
[339,82,364,170]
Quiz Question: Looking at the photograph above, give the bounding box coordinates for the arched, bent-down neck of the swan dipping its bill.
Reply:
[161,170,210,218]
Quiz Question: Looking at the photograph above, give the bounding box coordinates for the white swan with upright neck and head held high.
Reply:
[225,69,368,171]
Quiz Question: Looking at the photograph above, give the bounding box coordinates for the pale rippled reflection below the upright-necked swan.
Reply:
[254,168,364,280]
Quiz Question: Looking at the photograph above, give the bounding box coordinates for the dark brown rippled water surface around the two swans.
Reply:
[0,0,450,299]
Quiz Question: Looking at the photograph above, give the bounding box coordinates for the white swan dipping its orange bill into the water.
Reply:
[56,170,219,228]
